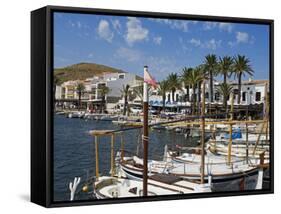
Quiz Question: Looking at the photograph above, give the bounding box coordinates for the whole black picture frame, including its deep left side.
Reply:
[31,6,274,207]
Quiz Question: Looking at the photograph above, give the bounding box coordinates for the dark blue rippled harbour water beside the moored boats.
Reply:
[54,115,197,201]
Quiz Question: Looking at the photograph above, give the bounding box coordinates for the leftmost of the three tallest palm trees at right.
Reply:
[204,54,218,102]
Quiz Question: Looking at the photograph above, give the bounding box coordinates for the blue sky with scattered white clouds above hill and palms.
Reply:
[54,13,269,81]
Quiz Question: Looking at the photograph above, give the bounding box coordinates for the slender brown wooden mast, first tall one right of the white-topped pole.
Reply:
[200,80,205,184]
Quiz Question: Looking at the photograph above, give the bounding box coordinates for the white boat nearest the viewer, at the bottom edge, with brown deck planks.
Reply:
[90,174,211,199]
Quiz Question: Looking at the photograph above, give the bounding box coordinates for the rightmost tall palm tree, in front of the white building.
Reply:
[233,55,254,104]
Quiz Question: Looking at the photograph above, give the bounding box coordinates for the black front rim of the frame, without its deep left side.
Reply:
[31,5,274,207]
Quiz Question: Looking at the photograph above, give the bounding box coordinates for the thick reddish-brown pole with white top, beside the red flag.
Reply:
[142,66,148,196]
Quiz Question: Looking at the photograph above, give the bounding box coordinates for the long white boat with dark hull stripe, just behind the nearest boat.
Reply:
[120,153,262,191]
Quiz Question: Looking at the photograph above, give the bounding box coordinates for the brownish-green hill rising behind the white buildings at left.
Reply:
[54,63,126,83]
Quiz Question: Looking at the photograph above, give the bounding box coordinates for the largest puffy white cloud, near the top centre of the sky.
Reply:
[125,17,149,46]
